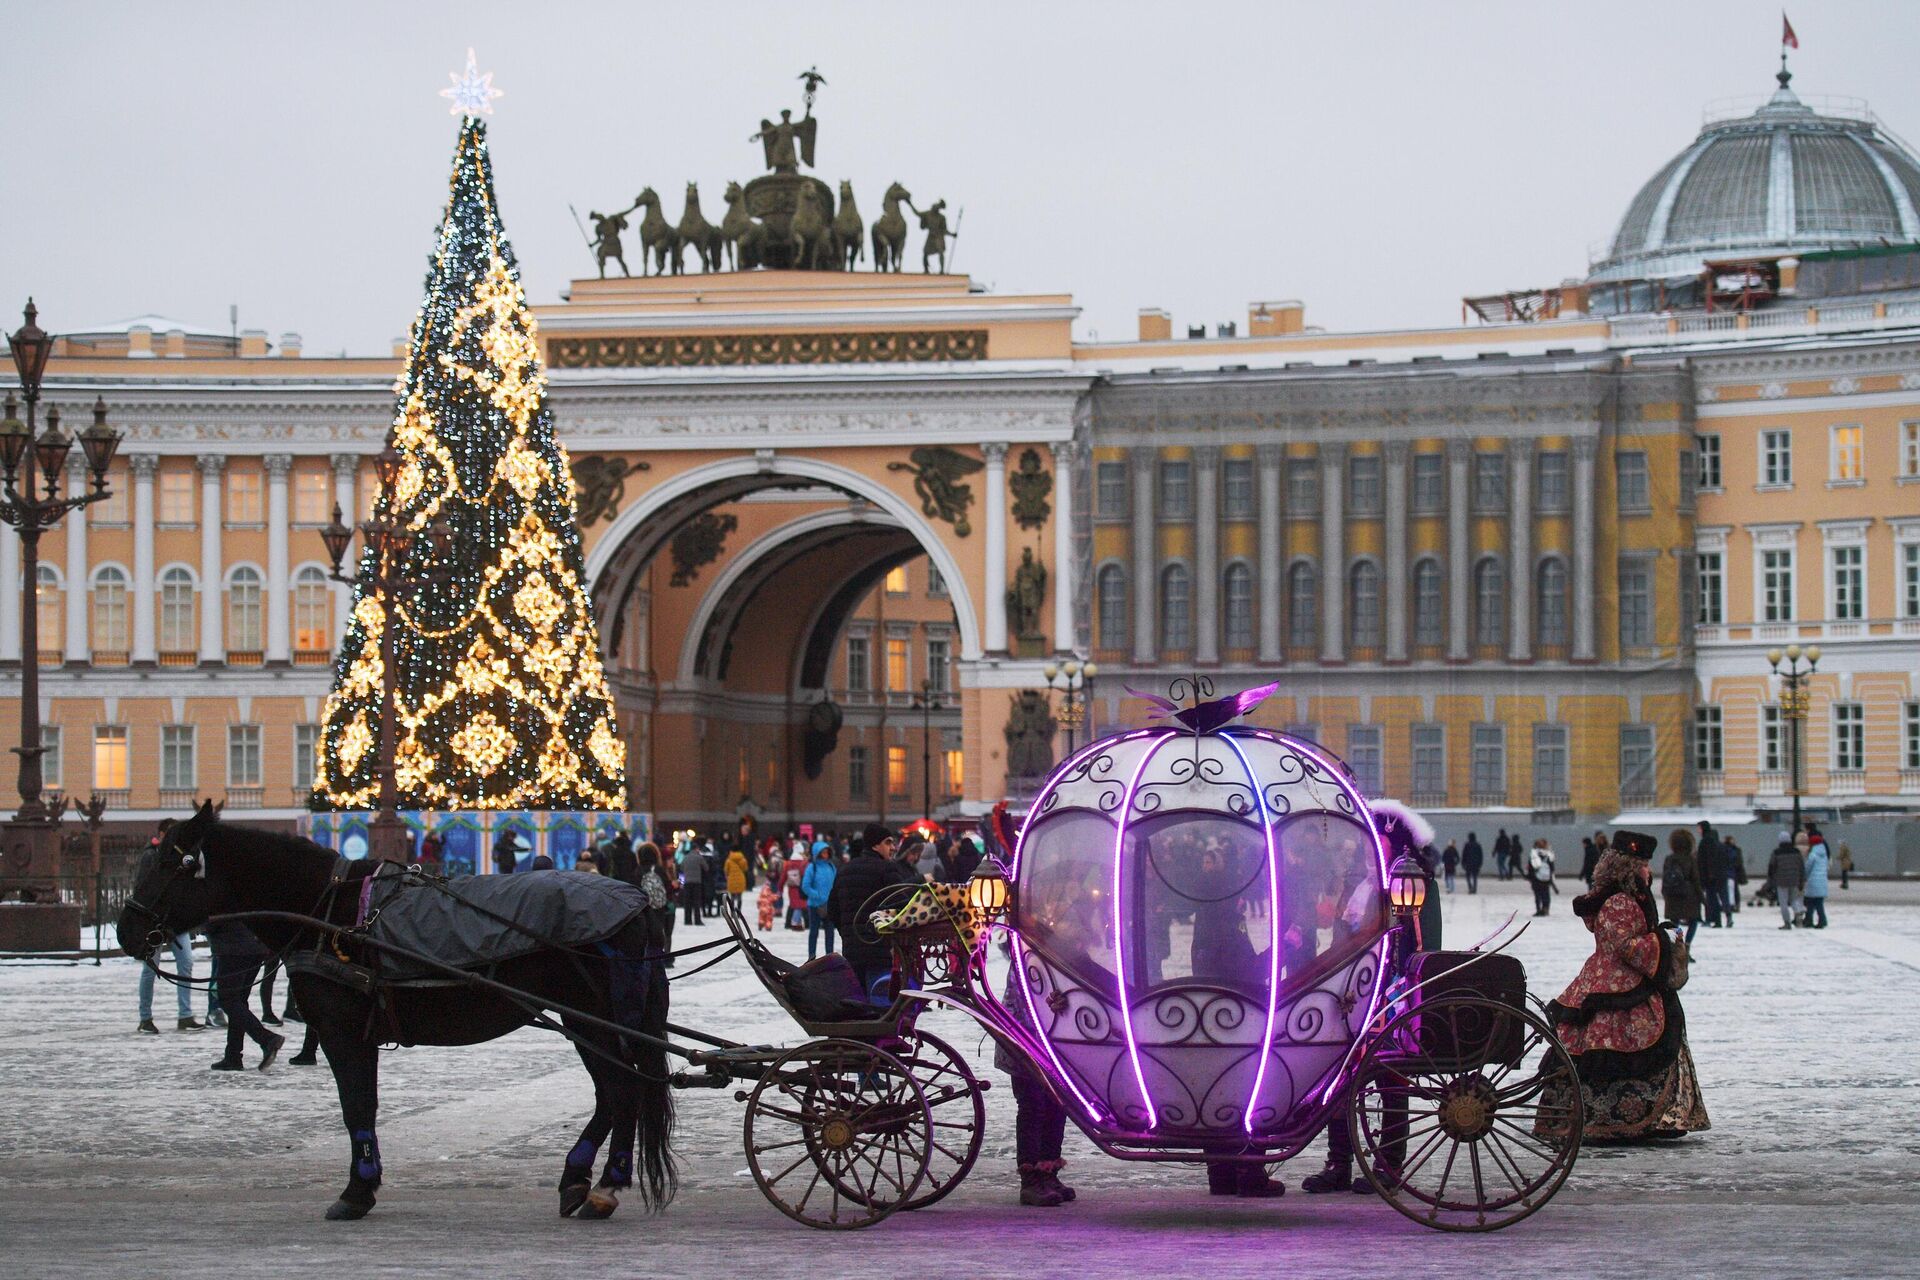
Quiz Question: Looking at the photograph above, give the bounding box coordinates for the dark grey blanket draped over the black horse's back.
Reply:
[359,867,647,981]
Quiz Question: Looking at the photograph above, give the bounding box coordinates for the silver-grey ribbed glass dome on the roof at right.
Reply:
[1588,77,1920,280]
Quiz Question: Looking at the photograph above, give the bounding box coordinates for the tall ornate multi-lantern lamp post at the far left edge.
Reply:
[0,297,121,875]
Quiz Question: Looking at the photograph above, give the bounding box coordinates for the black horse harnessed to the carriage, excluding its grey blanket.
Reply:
[117,804,678,1219]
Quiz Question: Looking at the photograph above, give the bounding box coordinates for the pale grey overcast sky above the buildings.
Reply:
[0,0,1920,355]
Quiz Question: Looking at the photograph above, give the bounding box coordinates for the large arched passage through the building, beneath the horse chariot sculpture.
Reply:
[595,476,966,831]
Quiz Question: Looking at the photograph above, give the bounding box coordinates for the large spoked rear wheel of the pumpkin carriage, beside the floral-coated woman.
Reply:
[1352,996,1584,1232]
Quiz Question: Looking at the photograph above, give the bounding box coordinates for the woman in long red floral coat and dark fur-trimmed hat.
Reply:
[1540,831,1711,1142]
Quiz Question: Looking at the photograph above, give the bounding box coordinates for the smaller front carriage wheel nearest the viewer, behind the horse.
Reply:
[745,1040,933,1230]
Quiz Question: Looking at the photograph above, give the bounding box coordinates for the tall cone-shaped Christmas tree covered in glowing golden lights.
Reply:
[313,92,626,810]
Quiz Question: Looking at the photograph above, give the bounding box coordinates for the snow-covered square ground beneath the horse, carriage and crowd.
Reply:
[0,881,1920,1280]
